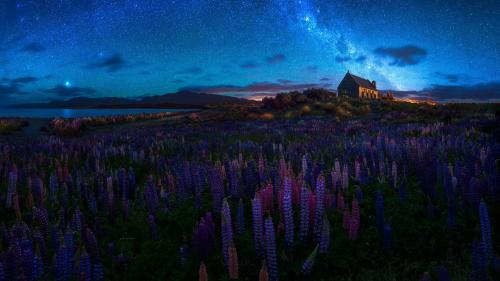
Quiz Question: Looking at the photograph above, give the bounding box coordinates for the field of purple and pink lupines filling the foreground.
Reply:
[0,115,500,281]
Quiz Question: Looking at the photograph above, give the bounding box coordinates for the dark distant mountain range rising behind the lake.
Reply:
[11,92,251,108]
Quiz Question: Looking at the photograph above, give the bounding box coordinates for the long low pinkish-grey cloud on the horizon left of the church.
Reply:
[179,82,332,95]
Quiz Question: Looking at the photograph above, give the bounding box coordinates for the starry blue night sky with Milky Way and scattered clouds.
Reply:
[0,0,500,104]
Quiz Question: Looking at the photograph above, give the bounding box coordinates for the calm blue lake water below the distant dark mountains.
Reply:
[0,108,192,118]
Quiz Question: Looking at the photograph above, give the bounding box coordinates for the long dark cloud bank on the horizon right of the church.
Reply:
[395,81,500,102]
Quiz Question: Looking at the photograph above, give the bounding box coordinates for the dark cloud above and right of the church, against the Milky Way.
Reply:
[374,45,427,66]
